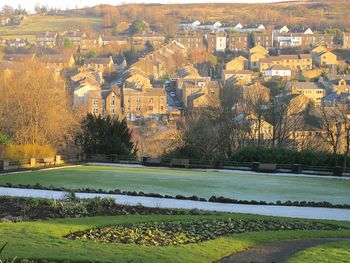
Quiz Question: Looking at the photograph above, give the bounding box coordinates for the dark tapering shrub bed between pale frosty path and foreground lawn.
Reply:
[0,194,213,222]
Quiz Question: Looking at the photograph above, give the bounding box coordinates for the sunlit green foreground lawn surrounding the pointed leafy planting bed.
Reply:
[0,214,350,263]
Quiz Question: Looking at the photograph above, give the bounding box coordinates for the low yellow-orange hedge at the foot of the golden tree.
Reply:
[5,144,56,161]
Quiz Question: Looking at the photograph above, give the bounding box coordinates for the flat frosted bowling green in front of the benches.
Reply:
[0,166,350,204]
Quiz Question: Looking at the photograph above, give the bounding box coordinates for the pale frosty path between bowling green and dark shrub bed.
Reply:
[0,187,350,221]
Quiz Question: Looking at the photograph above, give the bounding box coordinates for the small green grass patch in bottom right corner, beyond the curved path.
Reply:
[288,241,350,263]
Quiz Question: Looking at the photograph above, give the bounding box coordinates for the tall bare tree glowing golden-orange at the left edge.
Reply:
[0,61,76,146]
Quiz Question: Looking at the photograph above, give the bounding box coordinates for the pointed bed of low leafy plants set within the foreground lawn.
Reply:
[66,218,343,246]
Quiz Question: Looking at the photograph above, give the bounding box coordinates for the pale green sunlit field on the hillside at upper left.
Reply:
[0,15,101,36]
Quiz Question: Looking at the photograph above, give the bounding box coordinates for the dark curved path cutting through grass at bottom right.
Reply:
[216,238,350,263]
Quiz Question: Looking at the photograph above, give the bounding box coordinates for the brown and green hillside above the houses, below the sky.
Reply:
[0,0,350,38]
